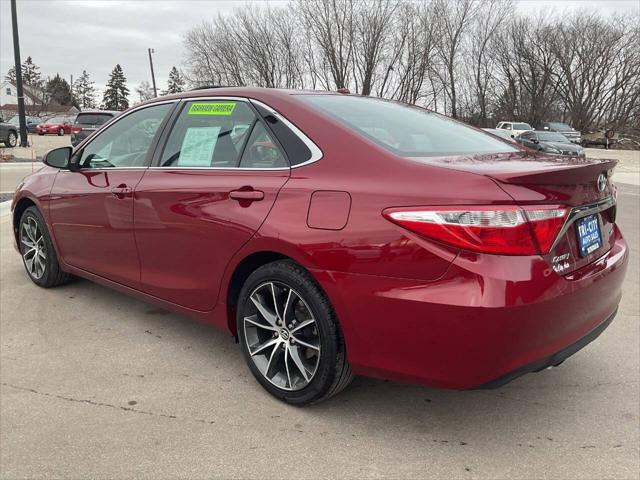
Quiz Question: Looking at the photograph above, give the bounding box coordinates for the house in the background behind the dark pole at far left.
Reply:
[0,80,79,121]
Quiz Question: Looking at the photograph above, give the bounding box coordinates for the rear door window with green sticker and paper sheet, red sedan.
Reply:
[160,100,258,168]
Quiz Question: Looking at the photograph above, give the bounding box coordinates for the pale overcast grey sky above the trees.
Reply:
[0,0,639,100]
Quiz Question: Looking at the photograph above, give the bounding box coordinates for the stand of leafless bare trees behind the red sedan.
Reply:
[184,0,640,129]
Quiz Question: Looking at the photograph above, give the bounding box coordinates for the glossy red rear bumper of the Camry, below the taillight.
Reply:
[313,228,628,389]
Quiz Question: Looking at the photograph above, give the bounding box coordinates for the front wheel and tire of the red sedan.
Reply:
[18,207,71,288]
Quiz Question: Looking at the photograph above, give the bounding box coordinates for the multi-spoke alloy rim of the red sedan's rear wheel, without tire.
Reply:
[243,281,321,391]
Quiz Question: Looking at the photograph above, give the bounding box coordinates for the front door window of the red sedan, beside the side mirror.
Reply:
[79,103,173,168]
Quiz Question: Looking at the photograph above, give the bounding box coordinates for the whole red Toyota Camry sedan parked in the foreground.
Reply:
[13,88,628,405]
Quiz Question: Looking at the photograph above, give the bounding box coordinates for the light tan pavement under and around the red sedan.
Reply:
[0,178,640,479]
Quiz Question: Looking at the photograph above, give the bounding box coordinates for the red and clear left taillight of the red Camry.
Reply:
[383,205,569,255]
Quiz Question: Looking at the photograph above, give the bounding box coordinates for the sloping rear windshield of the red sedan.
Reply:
[298,95,517,157]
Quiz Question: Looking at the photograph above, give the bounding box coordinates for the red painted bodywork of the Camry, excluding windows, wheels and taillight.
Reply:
[13,88,628,389]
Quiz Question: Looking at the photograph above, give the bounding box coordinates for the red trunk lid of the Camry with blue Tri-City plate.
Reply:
[418,152,617,275]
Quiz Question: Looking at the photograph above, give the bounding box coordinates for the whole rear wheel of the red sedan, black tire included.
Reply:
[236,260,353,405]
